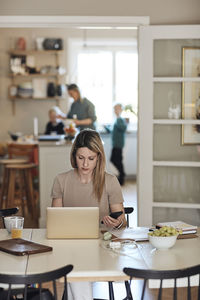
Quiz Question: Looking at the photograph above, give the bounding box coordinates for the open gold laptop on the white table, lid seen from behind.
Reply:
[47,207,99,239]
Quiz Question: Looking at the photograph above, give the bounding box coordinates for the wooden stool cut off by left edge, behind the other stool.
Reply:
[0,158,28,208]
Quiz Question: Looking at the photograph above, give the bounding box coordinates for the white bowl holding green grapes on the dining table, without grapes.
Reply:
[149,235,177,250]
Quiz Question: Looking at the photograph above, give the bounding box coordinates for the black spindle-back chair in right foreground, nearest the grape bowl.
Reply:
[123,265,200,300]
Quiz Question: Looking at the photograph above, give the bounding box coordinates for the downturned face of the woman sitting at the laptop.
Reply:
[76,147,98,175]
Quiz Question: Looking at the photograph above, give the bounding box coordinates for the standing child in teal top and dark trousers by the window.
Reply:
[110,103,127,185]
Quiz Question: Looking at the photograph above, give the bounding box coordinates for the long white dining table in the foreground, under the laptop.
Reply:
[0,229,200,287]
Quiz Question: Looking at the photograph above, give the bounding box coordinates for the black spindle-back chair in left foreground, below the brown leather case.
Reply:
[0,265,73,300]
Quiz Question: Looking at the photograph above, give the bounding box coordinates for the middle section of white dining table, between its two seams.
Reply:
[27,229,145,282]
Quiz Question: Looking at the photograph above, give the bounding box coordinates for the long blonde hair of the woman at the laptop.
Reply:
[70,129,106,201]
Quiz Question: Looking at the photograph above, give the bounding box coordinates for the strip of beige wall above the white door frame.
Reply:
[0,0,200,24]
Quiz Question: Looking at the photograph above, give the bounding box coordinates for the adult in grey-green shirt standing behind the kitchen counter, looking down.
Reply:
[58,83,97,130]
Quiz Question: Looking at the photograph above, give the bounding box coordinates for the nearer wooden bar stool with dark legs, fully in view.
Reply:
[2,164,38,217]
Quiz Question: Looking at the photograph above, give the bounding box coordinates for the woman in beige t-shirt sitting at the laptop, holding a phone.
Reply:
[52,129,126,300]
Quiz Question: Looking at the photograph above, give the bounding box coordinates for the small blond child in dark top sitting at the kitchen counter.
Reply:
[45,108,65,134]
